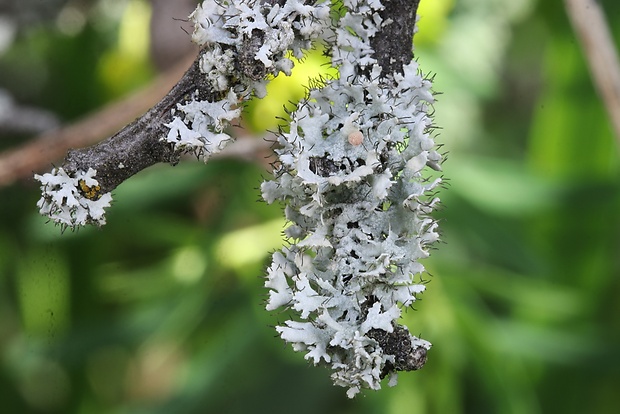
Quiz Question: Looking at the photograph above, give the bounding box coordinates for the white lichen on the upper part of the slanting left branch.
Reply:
[165,0,329,161]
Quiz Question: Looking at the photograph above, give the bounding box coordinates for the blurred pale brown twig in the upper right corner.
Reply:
[564,0,620,146]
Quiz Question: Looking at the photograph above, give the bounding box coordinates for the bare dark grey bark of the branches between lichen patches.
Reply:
[34,0,419,201]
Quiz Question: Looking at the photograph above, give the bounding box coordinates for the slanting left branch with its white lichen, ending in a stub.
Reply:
[35,0,329,227]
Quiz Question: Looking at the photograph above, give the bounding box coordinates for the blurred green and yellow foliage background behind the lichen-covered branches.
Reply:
[0,0,620,414]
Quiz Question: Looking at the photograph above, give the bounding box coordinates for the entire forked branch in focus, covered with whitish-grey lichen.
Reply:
[37,0,443,397]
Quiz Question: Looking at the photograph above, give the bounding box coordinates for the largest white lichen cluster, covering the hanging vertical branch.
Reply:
[261,0,442,397]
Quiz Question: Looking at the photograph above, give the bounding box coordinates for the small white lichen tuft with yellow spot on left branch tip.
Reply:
[34,168,112,228]
